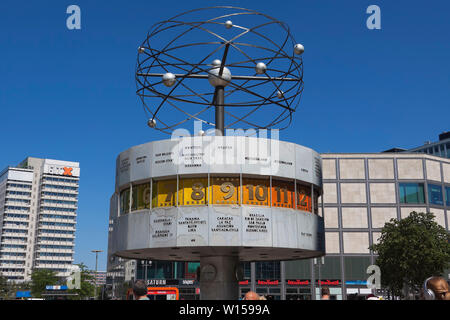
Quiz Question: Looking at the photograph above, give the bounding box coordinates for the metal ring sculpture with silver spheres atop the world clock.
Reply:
[135,6,304,134]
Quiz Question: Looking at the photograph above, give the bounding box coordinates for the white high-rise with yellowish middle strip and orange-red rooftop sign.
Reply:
[0,157,80,282]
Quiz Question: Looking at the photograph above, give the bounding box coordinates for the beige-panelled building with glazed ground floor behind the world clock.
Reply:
[106,153,450,300]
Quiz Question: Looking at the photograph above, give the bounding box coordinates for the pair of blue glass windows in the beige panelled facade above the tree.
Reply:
[399,183,450,206]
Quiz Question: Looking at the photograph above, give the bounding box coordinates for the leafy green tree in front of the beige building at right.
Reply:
[370,211,450,296]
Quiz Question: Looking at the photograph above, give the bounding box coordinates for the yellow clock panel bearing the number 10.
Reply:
[241,178,270,206]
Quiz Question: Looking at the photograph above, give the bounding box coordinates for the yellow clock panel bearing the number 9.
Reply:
[211,177,239,204]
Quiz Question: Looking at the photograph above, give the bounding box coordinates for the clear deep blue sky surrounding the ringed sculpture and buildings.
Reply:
[0,0,450,270]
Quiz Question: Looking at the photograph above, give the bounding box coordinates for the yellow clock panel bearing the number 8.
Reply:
[178,178,208,206]
